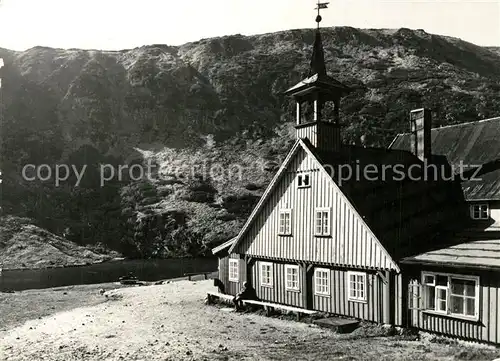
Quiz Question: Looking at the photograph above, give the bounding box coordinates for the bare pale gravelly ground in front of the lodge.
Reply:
[0,281,500,361]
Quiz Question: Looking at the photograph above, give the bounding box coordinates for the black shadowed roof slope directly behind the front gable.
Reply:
[316,146,467,260]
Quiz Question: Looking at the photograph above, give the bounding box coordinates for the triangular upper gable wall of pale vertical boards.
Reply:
[235,148,398,270]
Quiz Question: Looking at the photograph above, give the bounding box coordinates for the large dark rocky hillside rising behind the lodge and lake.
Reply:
[0,27,500,257]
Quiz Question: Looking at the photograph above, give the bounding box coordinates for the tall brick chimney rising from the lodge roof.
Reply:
[410,108,431,161]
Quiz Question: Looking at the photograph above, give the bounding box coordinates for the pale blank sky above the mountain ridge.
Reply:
[0,0,500,50]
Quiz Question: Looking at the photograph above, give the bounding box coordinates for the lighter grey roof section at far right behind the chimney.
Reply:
[390,117,500,201]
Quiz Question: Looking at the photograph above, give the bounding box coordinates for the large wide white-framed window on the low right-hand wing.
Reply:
[422,273,479,318]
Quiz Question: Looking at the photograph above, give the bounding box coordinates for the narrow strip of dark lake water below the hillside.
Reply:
[0,258,217,291]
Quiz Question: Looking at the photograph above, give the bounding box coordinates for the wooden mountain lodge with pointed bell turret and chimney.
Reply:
[209,11,500,343]
